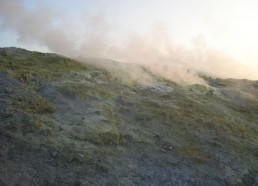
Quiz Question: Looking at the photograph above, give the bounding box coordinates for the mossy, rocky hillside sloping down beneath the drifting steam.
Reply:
[0,48,258,186]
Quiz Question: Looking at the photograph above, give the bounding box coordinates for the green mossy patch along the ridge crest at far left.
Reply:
[0,50,90,80]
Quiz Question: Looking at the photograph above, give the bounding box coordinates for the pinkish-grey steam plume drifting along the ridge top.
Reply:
[0,0,258,83]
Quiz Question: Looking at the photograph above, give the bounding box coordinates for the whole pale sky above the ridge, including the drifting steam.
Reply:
[0,0,258,79]
